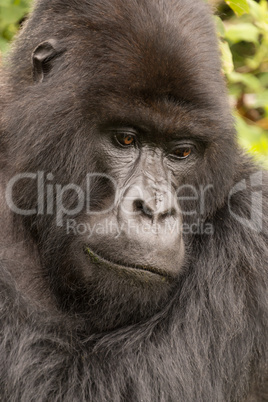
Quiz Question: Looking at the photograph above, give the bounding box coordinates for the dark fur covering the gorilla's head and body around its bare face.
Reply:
[0,0,268,402]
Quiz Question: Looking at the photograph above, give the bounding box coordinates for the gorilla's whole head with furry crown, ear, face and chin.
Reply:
[5,0,235,330]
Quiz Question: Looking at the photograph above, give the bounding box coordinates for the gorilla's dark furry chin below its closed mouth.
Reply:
[65,243,178,333]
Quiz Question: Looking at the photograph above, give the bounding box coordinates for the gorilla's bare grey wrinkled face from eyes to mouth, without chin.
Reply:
[83,125,184,278]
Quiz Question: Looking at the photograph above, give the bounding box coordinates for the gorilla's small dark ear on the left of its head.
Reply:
[32,39,65,82]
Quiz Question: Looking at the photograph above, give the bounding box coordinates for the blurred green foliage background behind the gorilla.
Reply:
[0,0,268,168]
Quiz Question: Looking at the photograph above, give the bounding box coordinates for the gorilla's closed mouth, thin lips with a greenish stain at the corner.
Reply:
[85,247,174,280]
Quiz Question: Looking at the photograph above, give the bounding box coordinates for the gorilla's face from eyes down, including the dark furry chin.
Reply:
[39,103,188,330]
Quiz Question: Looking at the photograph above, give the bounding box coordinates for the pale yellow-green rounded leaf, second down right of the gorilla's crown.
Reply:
[225,23,260,44]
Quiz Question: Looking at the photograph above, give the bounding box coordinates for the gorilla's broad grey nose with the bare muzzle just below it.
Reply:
[118,186,182,250]
